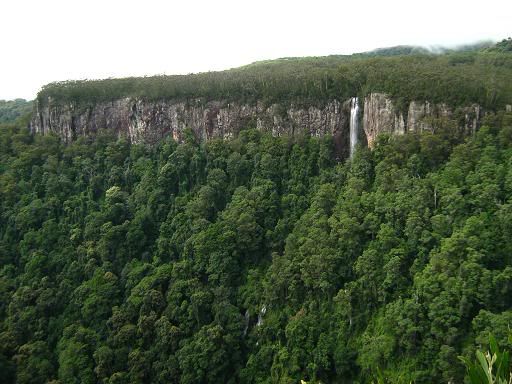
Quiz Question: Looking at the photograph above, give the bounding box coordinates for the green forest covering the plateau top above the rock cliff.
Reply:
[38,40,512,110]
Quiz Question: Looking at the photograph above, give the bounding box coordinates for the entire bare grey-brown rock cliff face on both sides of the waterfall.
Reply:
[31,93,482,152]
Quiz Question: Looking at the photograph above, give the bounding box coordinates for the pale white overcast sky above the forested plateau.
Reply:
[0,0,512,99]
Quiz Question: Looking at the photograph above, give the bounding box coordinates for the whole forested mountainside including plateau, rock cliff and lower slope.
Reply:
[5,41,512,384]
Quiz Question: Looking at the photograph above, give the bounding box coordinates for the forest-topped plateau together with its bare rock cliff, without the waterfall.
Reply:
[31,43,512,153]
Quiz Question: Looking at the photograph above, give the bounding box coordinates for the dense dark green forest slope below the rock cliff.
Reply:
[0,106,512,384]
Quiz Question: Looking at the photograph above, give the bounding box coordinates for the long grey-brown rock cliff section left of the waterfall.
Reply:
[31,98,350,154]
